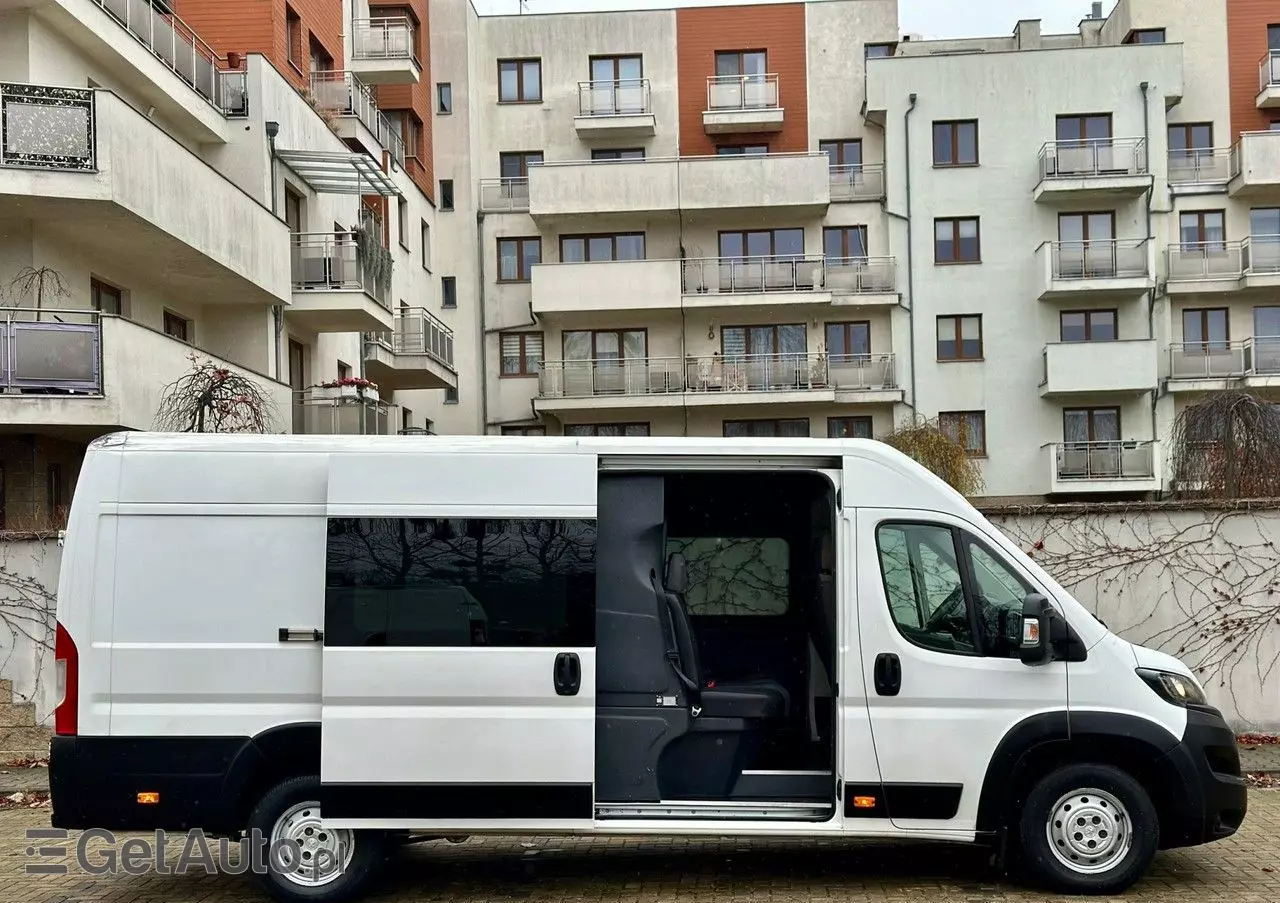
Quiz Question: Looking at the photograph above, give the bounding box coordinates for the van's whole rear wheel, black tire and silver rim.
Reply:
[248,775,384,903]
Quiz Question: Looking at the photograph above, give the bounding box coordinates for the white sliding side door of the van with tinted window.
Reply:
[320,448,596,830]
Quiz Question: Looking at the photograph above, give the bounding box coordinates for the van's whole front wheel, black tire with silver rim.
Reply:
[1016,763,1160,894]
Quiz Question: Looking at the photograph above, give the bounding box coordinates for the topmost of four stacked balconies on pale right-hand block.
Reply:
[1036,138,1152,204]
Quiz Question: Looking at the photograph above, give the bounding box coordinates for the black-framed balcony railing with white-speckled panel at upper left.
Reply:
[0,83,97,172]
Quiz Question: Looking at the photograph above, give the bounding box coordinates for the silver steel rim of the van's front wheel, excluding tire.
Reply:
[1046,788,1133,875]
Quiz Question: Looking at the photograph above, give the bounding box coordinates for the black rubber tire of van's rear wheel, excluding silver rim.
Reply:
[247,775,385,903]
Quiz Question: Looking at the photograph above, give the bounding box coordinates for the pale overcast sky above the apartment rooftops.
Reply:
[472,0,1115,38]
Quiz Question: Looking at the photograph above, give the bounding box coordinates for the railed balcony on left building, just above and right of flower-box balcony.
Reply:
[365,307,458,391]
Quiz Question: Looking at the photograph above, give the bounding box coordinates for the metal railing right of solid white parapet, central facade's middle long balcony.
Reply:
[681,257,897,295]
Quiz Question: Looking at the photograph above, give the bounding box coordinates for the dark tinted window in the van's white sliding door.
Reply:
[324,517,595,647]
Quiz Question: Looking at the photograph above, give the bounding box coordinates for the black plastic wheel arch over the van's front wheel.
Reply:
[978,711,1183,849]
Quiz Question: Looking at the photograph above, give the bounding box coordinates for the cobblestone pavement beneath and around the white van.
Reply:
[0,790,1280,903]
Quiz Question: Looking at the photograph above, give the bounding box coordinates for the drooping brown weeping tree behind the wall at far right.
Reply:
[1171,392,1280,500]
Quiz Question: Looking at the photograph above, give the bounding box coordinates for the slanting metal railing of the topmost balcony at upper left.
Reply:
[92,0,244,115]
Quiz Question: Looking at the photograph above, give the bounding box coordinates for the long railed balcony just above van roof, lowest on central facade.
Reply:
[535,352,902,411]
